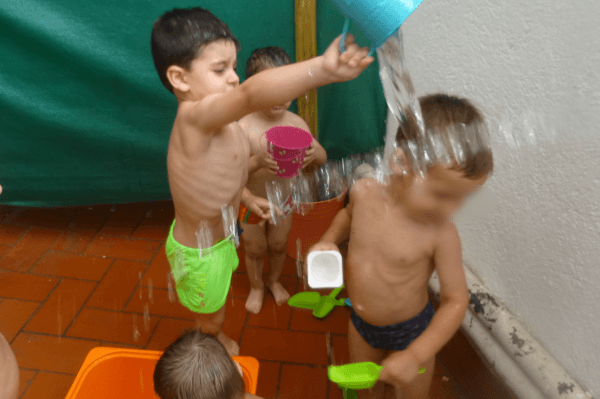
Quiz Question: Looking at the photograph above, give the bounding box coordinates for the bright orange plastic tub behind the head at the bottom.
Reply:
[66,347,258,399]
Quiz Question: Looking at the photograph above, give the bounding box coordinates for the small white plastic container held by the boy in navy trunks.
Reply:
[307,251,344,288]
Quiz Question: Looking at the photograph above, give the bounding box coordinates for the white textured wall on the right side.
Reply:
[403,0,600,397]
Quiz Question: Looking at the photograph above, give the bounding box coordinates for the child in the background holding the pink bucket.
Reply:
[239,47,327,313]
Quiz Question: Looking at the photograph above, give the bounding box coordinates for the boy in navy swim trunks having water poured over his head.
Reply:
[311,95,493,399]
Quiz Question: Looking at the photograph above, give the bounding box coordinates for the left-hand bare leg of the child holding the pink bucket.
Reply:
[241,223,267,313]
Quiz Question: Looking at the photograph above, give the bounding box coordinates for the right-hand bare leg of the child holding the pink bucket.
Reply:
[267,213,292,305]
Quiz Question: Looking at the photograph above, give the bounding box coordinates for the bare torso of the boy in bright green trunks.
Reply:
[167,107,250,247]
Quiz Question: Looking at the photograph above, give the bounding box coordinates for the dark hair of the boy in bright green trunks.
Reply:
[151,7,240,93]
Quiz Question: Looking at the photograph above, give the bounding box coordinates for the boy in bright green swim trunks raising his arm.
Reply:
[151,8,374,355]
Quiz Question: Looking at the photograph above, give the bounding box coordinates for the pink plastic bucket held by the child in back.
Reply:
[265,126,313,178]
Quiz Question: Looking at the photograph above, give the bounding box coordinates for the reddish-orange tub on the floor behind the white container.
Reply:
[286,191,347,259]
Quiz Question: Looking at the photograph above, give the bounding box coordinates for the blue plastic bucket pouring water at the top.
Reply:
[331,0,423,53]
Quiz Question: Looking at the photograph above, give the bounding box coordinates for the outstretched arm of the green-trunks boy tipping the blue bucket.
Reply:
[190,35,374,132]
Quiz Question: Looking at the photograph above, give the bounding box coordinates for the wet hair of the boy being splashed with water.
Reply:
[396,94,494,179]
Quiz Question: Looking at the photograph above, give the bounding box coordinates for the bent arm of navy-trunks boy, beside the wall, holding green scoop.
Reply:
[380,223,469,384]
